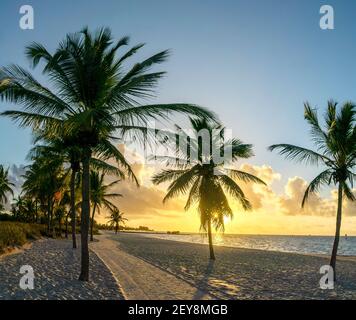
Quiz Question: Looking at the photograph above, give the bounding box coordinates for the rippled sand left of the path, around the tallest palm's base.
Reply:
[0,238,123,300]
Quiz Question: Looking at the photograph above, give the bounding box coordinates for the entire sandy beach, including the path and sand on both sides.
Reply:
[0,231,356,300]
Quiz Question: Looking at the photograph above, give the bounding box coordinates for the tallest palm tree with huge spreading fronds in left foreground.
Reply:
[0,28,214,281]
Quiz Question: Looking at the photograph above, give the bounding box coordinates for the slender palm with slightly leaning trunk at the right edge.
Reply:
[269,101,356,280]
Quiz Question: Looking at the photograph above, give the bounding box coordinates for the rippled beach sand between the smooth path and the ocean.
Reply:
[99,232,356,300]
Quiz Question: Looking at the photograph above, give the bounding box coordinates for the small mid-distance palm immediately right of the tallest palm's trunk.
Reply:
[90,170,122,241]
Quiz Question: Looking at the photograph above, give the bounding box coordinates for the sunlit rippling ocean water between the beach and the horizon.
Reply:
[138,233,356,256]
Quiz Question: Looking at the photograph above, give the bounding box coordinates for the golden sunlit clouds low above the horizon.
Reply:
[102,145,356,233]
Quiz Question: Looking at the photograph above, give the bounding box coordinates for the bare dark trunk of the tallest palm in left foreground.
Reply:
[79,150,91,281]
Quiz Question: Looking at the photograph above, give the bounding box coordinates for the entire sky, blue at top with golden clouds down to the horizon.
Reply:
[0,0,356,234]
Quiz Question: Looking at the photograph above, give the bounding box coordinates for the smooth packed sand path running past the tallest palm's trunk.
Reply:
[90,231,212,300]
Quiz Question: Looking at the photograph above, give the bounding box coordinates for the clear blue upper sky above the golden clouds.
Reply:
[0,0,356,188]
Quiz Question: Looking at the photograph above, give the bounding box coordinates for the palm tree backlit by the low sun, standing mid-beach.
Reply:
[152,119,265,260]
